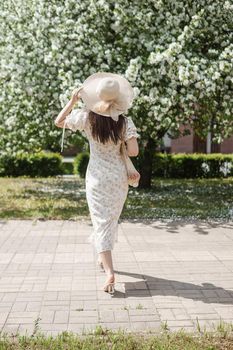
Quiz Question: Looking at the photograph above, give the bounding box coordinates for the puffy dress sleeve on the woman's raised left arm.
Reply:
[65,109,88,131]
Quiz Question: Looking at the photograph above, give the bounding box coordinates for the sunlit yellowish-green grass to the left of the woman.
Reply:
[0,177,89,220]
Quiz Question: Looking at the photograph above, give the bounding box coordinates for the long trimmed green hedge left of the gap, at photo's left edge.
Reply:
[0,152,63,177]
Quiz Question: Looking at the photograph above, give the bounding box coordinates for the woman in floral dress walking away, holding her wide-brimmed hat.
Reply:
[55,72,140,293]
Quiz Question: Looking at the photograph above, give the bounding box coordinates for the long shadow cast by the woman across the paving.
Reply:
[111,270,233,305]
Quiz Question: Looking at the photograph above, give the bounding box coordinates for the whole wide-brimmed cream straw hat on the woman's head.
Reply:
[79,72,134,121]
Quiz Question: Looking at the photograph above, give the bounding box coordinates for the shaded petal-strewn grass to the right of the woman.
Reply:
[124,177,233,221]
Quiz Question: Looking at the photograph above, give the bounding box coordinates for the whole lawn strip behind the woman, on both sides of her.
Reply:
[0,176,233,220]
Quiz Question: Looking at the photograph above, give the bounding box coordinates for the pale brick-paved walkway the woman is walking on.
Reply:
[0,220,233,334]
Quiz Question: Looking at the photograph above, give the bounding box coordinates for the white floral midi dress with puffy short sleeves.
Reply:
[65,108,140,253]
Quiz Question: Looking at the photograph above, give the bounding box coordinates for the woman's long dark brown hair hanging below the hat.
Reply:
[88,111,126,144]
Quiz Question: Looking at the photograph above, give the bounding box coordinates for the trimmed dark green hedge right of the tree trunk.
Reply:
[153,153,233,178]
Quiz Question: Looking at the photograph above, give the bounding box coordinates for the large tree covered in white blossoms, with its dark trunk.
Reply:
[0,0,233,187]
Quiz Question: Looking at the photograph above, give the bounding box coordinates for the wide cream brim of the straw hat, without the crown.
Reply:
[79,72,134,116]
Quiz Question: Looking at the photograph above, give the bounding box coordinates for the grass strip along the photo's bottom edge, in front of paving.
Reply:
[0,323,233,350]
